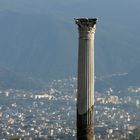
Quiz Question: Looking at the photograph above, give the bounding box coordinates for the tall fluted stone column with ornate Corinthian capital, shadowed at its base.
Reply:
[75,18,97,140]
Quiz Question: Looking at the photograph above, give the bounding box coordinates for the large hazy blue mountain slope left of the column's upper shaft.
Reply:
[0,12,77,80]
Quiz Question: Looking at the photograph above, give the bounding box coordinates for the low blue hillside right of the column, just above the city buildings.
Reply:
[95,65,140,90]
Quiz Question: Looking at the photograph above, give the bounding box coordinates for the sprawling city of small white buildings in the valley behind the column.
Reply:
[0,77,140,140]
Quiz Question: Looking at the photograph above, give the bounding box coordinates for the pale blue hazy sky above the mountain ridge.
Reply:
[0,0,140,26]
